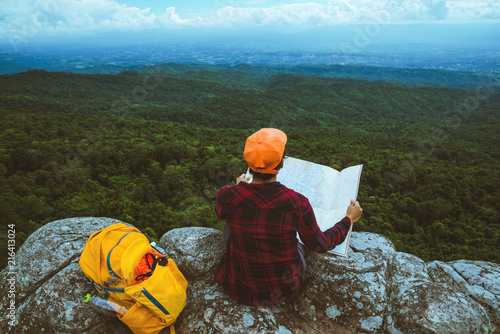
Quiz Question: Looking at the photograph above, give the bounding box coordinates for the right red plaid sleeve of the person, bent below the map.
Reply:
[299,197,351,253]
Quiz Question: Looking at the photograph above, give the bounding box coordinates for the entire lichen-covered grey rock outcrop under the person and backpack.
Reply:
[0,218,500,334]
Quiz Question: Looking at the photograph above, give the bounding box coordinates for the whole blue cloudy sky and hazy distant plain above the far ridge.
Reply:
[0,0,500,73]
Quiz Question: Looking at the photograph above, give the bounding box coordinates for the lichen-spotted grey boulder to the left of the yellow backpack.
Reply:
[0,218,130,333]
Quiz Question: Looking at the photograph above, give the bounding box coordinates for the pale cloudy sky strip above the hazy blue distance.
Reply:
[0,0,500,40]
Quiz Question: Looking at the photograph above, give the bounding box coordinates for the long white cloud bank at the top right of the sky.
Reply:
[200,0,500,26]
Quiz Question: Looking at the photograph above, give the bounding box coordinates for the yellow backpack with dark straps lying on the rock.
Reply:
[79,223,187,334]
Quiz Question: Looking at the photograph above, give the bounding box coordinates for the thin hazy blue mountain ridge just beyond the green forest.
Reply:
[0,54,499,90]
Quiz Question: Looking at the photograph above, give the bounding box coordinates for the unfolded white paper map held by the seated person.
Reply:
[277,157,363,256]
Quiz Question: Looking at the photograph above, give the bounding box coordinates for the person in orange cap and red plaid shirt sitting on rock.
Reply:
[215,128,362,305]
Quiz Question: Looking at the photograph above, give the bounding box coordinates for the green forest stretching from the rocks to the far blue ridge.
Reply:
[0,66,500,268]
